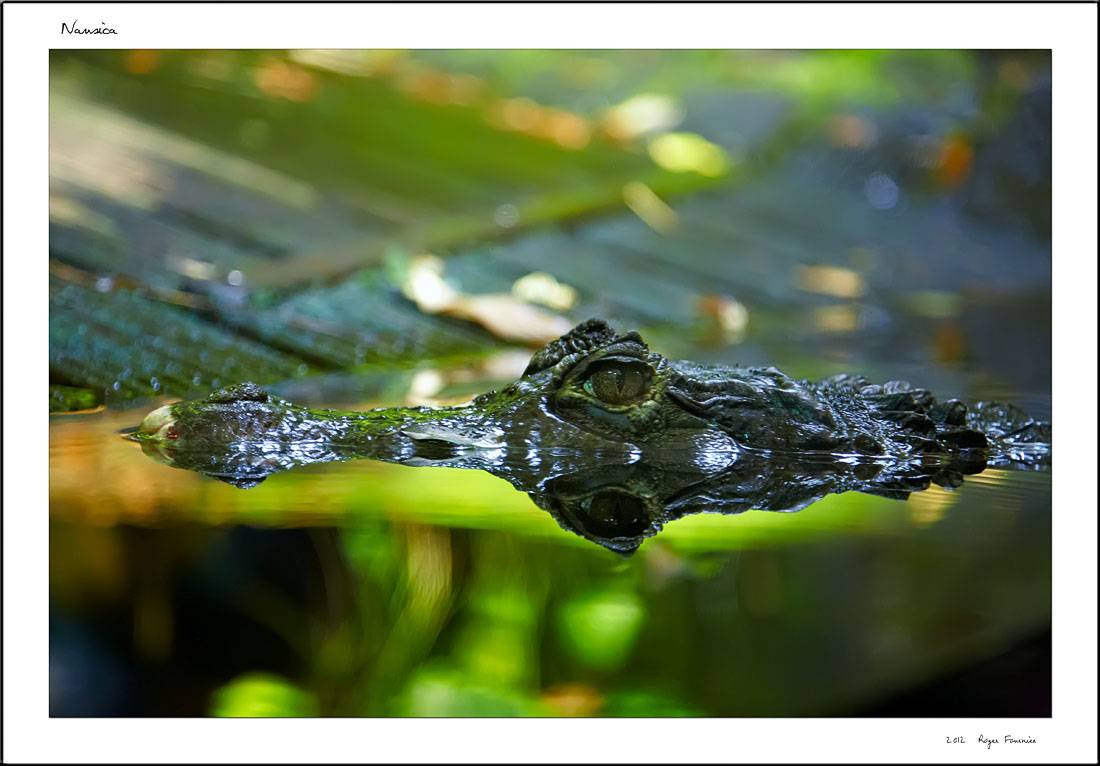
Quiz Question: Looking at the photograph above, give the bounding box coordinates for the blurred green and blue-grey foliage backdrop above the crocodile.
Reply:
[51,51,1049,406]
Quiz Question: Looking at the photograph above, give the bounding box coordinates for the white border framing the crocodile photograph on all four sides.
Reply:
[2,3,1097,763]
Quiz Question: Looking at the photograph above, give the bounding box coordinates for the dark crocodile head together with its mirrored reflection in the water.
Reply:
[130,319,1049,550]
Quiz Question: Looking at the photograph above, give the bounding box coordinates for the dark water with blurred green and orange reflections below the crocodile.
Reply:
[50,367,1051,715]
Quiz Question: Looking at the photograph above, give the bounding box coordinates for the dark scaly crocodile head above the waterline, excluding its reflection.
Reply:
[131,319,1049,486]
